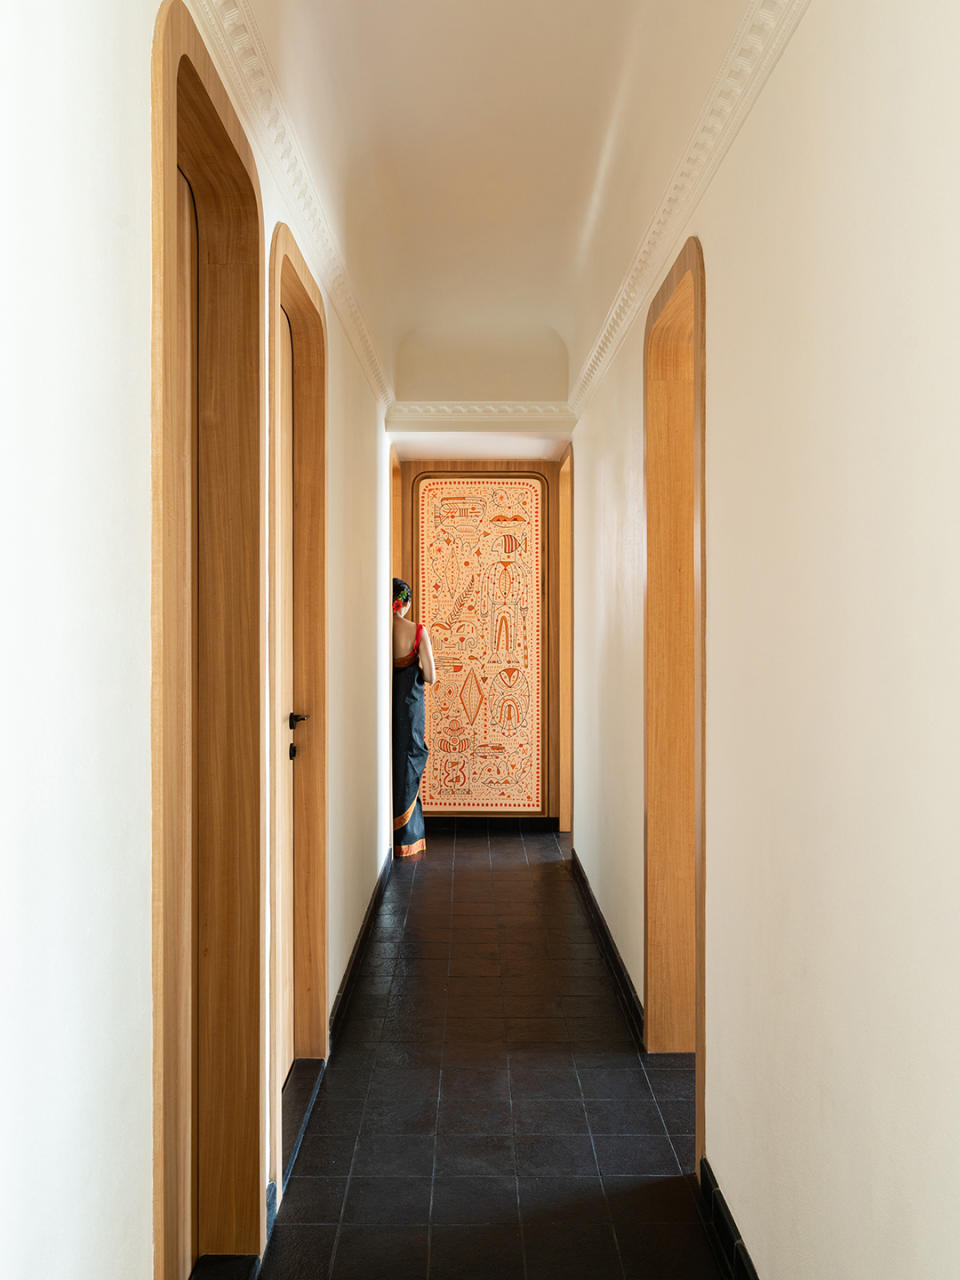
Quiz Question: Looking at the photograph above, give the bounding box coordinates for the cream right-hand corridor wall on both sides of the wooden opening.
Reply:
[575,0,960,1280]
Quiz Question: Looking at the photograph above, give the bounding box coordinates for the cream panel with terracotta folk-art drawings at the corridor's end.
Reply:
[419,476,543,813]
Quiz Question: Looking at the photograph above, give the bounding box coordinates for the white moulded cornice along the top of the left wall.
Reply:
[187,0,393,406]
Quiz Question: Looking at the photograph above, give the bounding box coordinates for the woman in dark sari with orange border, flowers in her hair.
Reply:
[393,577,436,858]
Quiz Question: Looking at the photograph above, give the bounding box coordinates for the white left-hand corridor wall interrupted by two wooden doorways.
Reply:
[0,0,390,1280]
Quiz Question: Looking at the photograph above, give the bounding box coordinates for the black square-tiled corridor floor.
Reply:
[261,819,719,1280]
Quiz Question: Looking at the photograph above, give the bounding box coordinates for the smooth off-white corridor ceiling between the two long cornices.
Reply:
[250,0,745,399]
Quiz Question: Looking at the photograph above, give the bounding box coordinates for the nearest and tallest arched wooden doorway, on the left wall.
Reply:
[152,0,266,1280]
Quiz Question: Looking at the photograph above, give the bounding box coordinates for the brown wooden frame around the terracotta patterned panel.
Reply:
[399,456,572,818]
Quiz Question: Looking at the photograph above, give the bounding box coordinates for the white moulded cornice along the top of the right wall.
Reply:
[570,0,809,417]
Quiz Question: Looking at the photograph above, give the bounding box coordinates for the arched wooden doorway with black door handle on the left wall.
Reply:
[270,224,329,1190]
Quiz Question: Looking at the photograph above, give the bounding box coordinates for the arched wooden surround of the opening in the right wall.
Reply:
[644,238,705,1162]
